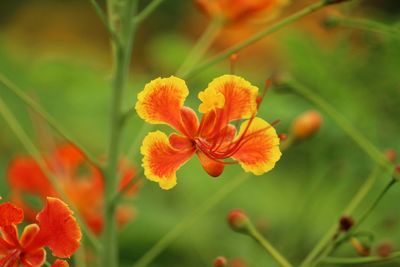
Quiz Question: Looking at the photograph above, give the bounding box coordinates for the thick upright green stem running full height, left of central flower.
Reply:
[101,0,138,267]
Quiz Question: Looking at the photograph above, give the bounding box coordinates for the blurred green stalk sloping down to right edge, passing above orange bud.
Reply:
[288,79,400,181]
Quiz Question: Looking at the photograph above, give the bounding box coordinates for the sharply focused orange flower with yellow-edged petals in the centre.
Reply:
[136,75,281,189]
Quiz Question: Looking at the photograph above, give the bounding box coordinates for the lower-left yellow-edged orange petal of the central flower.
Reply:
[140,131,194,189]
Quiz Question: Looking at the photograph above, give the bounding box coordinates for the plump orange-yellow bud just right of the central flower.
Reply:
[292,110,322,139]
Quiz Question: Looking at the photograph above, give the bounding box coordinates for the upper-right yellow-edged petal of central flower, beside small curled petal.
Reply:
[205,75,258,122]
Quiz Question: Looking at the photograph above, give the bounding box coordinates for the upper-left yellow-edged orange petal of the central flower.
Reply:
[135,76,189,133]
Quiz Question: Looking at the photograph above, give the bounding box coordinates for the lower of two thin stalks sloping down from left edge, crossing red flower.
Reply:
[0,97,100,250]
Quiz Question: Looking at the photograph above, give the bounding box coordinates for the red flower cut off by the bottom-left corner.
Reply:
[0,197,82,267]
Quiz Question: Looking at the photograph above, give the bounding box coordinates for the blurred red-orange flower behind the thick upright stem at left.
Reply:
[8,144,137,234]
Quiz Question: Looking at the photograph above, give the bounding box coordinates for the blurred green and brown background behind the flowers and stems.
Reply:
[0,0,400,267]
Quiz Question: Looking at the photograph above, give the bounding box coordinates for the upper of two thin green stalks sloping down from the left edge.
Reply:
[0,73,101,170]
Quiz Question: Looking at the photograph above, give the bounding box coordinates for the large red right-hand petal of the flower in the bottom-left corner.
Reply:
[37,197,82,258]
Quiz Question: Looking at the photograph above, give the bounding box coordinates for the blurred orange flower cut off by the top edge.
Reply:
[196,0,288,23]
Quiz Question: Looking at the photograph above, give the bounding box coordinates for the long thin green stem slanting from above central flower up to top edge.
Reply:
[181,0,329,78]
